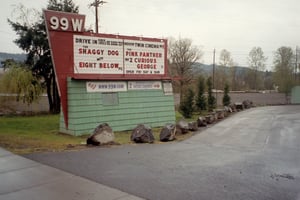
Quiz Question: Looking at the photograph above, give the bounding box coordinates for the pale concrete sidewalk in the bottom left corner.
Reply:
[0,147,142,200]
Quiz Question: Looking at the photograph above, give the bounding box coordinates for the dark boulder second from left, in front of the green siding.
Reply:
[130,124,154,143]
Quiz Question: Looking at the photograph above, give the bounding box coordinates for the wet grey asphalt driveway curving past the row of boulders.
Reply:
[27,106,300,200]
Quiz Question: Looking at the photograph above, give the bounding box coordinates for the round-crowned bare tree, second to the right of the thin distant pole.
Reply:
[248,47,267,90]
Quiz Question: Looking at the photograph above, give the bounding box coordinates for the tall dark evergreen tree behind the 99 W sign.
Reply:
[8,0,78,113]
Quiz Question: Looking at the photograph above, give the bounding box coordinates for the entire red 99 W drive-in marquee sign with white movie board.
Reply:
[44,10,169,126]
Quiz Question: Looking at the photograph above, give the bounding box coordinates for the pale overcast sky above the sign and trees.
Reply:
[0,0,300,69]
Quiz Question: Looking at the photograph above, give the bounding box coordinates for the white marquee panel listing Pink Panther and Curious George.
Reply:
[124,40,165,75]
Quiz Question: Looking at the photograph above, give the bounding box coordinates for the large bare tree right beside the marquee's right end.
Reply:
[169,38,203,99]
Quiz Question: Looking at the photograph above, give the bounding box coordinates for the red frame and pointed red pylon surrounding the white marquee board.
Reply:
[44,10,171,129]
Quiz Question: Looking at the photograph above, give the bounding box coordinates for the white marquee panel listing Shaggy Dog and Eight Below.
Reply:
[73,35,123,74]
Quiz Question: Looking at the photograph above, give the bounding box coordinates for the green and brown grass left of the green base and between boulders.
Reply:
[0,115,193,154]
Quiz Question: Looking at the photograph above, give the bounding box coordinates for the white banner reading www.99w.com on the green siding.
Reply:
[86,81,127,92]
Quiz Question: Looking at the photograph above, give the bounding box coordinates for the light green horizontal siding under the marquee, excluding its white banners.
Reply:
[60,79,175,135]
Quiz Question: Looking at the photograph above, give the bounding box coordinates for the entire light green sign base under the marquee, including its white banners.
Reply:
[60,78,175,136]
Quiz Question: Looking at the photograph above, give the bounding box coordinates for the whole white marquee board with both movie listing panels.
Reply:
[73,35,165,76]
